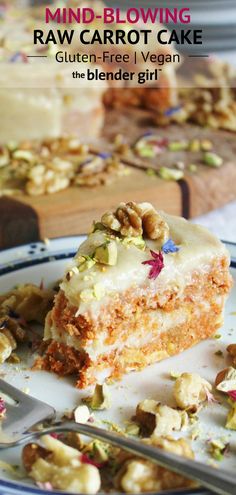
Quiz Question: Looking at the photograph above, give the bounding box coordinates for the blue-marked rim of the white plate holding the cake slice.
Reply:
[0,235,236,495]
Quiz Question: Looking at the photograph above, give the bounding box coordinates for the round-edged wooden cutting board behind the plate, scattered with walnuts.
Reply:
[0,110,236,248]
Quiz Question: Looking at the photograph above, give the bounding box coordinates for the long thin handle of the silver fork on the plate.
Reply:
[21,423,236,495]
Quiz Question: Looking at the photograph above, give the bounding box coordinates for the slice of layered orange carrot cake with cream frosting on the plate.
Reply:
[42,202,231,387]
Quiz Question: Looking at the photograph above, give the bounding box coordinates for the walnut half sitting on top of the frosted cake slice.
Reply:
[101,201,169,244]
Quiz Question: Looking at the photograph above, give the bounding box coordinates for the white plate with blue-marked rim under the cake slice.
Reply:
[0,236,236,495]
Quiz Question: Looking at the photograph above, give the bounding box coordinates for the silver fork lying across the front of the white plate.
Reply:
[0,380,236,495]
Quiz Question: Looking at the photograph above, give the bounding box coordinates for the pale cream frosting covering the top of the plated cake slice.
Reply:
[61,212,228,318]
